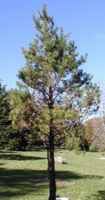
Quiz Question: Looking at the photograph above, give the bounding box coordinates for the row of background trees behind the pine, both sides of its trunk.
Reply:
[0,79,101,151]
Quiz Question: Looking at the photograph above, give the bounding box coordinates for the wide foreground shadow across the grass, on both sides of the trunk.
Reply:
[0,168,103,200]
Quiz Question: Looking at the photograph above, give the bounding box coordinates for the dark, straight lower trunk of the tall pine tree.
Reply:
[47,86,56,200]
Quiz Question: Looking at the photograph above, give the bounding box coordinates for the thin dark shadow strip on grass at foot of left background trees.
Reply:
[0,151,46,161]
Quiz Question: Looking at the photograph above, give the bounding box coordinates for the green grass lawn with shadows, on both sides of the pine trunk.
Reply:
[0,151,105,200]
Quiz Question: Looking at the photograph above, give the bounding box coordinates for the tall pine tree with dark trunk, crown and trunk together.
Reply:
[12,7,98,200]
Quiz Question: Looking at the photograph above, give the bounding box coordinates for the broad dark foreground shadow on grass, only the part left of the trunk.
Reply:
[0,168,48,199]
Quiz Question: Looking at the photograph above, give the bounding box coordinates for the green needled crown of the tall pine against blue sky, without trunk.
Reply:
[19,7,99,130]
